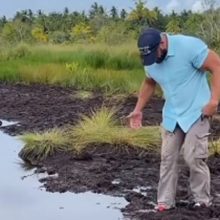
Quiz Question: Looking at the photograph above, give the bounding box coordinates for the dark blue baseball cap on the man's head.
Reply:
[138,28,161,66]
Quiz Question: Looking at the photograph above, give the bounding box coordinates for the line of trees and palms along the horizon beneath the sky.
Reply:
[0,0,220,49]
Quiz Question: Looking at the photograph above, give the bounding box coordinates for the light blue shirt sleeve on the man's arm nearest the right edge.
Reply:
[191,38,209,69]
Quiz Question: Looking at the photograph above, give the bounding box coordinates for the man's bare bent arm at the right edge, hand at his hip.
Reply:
[202,50,220,116]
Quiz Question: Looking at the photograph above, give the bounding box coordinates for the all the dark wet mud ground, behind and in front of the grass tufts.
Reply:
[0,84,220,220]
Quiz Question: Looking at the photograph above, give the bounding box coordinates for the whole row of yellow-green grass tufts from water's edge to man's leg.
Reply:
[22,108,160,159]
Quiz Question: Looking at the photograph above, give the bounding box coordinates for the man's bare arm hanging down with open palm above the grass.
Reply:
[127,78,156,129]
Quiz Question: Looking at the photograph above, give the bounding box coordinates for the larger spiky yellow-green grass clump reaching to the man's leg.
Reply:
[69,108,160,152]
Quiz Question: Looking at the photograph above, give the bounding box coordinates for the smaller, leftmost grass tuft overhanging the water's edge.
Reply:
[21,128,68,160]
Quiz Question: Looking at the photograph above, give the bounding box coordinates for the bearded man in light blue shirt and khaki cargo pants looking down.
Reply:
[128,28,220,211]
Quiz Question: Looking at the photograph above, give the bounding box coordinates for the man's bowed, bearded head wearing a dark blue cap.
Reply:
[138,28,167,66]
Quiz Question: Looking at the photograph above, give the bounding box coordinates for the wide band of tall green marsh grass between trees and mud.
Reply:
[0,44,144,93]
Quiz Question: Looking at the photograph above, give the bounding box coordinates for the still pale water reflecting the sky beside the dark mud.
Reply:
[0,121,127,220]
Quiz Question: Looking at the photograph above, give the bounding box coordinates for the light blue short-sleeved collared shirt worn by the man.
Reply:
[145,35,211,132]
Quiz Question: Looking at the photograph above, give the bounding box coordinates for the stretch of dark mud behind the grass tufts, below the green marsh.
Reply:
[0,84,162,135]
